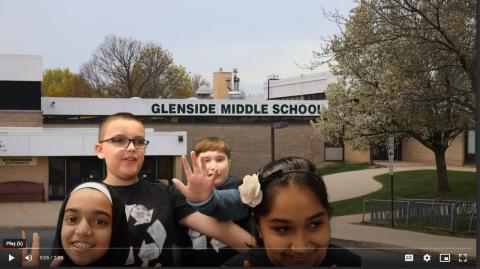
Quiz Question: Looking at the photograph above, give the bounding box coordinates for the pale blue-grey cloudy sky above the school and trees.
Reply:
[0,0,355,94]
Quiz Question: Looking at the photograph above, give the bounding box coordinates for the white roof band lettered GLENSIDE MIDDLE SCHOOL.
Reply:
[42,97,326,117]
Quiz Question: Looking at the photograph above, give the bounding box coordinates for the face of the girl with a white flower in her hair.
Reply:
[257,184,330,266]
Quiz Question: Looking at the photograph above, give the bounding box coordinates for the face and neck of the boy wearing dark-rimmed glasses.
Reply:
[95,118,145,186]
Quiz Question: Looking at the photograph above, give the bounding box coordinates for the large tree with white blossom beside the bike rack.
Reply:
[311,0,476,192]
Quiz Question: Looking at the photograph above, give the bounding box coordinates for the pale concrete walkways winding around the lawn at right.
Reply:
[324,162,476,257]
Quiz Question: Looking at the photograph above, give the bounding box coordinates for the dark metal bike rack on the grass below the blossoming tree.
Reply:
[362,198,477,233]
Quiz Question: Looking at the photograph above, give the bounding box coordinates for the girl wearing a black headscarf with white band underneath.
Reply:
[24,182,128,266]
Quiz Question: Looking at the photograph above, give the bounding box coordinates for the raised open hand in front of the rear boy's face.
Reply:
[172,151,219,203]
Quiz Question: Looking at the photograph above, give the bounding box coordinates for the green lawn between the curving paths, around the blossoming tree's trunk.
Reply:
[331,170,476,216]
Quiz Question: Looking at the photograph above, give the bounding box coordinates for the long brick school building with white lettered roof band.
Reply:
[0,55,474,201]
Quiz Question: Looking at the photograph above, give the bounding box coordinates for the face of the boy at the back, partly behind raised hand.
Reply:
[199,151,231,187]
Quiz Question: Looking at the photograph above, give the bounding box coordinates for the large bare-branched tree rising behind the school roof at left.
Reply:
[80,36,193,98]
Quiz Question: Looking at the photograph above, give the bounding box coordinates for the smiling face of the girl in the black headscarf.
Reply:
[61,188,112,265]
